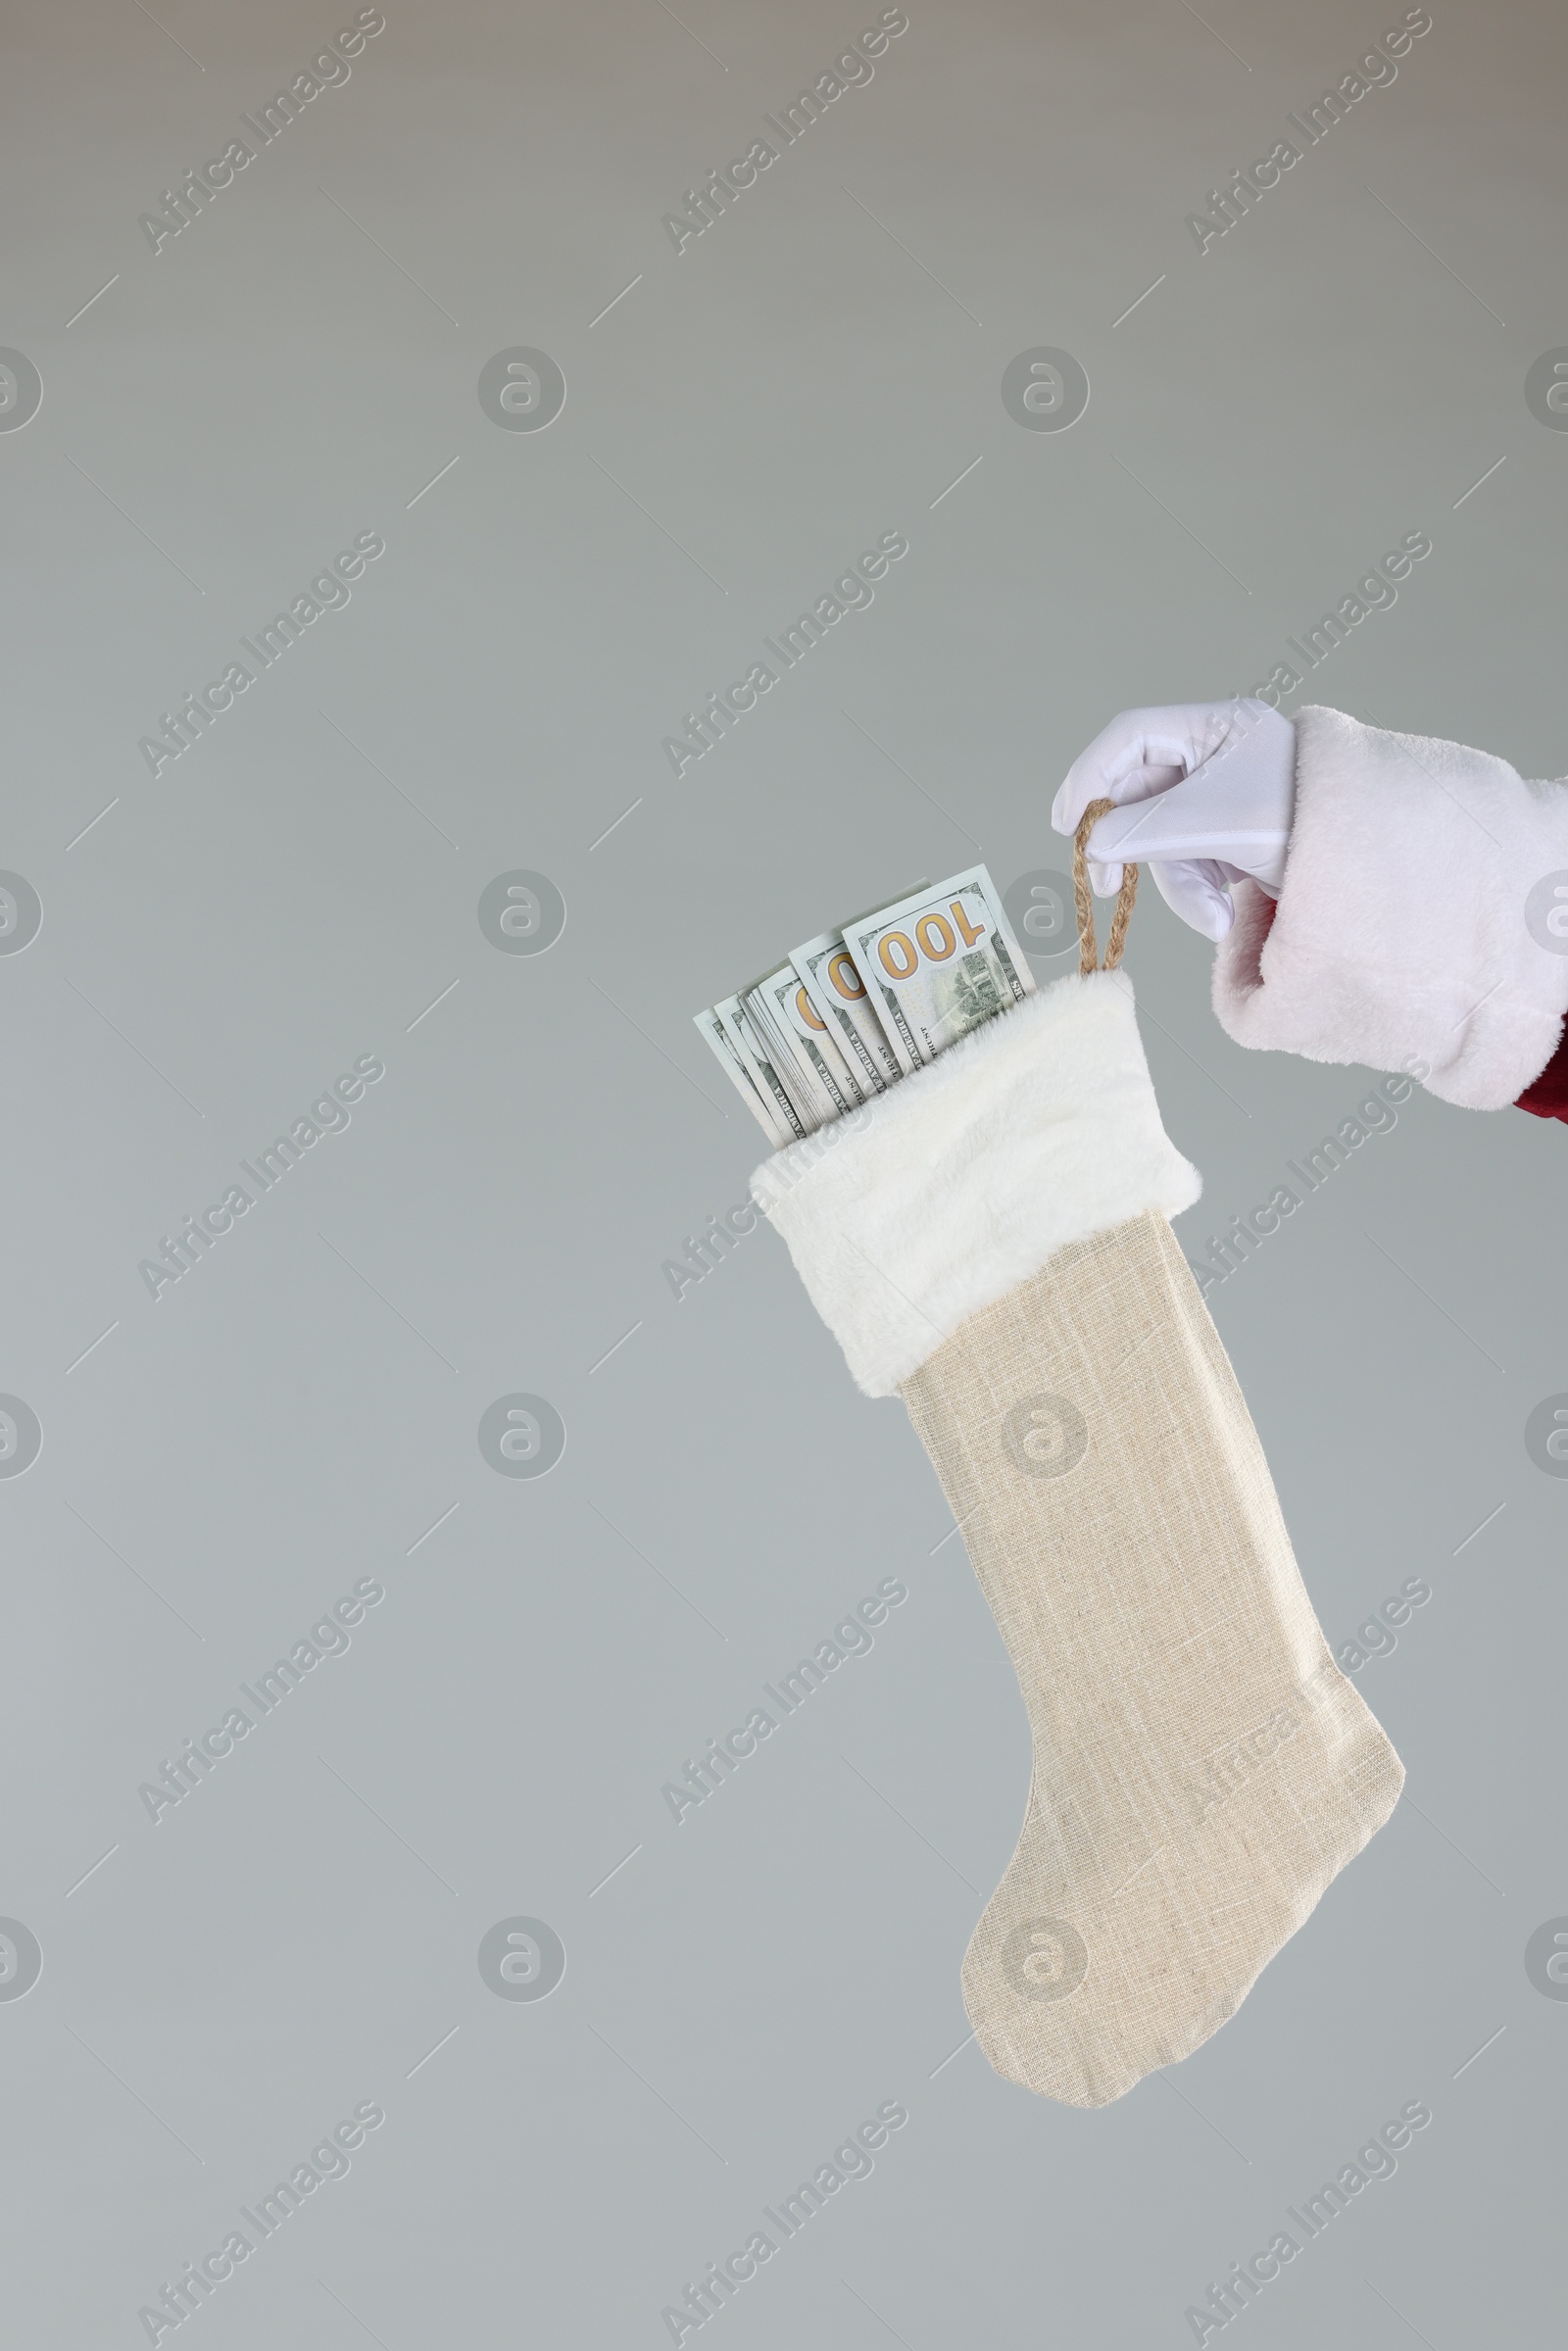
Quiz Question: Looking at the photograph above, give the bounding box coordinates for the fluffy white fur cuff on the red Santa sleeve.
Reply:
[1213,708,1568,1109]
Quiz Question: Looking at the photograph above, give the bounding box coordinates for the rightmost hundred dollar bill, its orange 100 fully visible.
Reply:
[844,865,1034,1077]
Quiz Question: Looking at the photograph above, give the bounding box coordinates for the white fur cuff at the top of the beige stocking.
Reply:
[753,971,1201,1396]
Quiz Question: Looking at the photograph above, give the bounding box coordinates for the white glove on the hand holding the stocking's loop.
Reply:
[1051,696,1296,938]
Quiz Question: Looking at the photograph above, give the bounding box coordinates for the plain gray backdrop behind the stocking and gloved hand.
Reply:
[0,0,1568,2351]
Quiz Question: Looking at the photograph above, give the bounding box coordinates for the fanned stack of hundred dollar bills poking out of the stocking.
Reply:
[696,865,1034,1150]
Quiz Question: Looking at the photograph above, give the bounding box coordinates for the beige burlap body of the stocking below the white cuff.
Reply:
[901,1210,1403,2107]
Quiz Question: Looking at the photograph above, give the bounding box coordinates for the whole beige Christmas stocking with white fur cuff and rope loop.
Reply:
[753,802,1403,2107]
